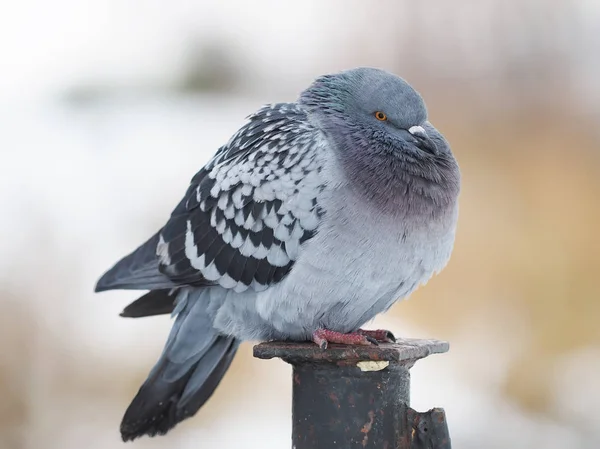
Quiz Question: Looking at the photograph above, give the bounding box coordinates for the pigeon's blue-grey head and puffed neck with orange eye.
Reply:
[299,68,460,212]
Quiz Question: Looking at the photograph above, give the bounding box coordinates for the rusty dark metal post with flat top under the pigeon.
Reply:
[254,339,450,449]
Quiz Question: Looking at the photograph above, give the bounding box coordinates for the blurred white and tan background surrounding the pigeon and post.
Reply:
[0,0,600,449]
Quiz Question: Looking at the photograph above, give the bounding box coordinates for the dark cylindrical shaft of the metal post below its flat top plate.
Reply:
[292,356,409,449]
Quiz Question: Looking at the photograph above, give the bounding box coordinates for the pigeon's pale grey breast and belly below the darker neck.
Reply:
[215,170,456,339]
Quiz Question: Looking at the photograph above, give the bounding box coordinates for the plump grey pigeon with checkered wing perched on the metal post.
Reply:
[96,67,460,441]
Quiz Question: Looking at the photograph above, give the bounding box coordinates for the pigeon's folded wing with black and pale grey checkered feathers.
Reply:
[156,103,323,291]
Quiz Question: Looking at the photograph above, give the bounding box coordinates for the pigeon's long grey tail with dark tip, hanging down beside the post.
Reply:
[121,291,239,441]
